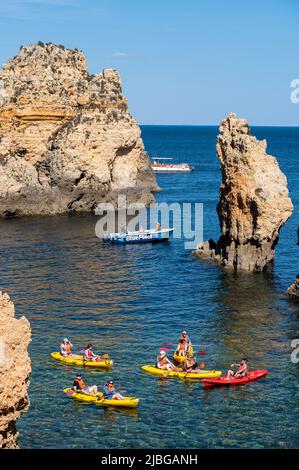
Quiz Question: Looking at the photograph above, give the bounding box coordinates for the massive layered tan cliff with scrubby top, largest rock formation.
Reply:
[0,43,158,216]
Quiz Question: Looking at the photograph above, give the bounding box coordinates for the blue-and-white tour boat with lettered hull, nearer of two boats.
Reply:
[103,228,174,244]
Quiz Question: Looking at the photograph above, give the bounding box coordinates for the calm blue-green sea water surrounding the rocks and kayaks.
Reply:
[0,126,299,448]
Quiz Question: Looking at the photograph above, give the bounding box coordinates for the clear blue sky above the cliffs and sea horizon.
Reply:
[0,0,299,125]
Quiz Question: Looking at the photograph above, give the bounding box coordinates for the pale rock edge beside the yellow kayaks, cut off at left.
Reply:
[0,292,31,449]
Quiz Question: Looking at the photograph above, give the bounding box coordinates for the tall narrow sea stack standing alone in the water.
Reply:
[195,114,293,271]
